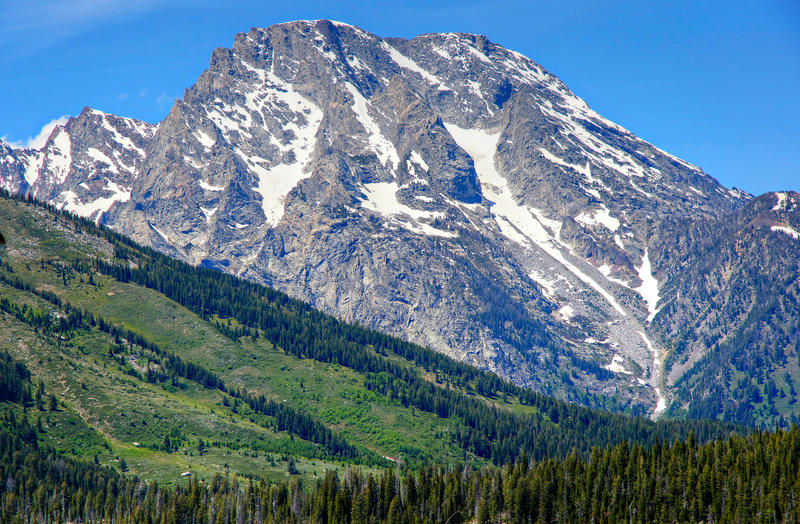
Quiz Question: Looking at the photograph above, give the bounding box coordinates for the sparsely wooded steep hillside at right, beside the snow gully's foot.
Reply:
[651,192,800,427]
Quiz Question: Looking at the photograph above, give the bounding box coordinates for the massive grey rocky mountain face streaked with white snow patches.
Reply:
[0,20,797,422]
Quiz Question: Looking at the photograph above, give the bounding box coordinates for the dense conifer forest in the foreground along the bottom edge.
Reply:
[0,400,800,524]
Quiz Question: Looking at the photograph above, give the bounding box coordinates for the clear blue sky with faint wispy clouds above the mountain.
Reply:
[0,0,800,194]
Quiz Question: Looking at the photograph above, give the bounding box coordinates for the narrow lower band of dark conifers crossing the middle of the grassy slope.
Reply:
[0,273,356,462]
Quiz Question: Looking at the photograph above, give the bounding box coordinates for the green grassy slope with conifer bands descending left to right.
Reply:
[0,190,730,481]
